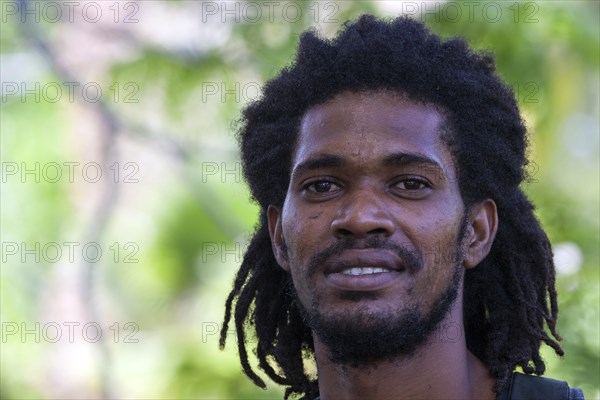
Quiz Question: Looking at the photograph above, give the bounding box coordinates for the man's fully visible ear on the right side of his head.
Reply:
[463,199,498,268]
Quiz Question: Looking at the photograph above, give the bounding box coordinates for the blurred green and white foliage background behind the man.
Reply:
[0,0,600,399]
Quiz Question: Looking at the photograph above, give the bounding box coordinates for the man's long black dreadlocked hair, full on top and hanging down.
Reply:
[220,15,563,398]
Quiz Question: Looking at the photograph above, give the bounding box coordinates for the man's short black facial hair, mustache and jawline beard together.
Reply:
[290,219,466,368]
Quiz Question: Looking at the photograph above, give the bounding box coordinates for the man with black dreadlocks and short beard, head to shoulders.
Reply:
[221,16,583,400]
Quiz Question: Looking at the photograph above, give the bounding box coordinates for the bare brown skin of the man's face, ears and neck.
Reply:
[268,92,498,400]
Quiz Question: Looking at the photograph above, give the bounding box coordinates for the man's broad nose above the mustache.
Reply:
[331,190,396,239]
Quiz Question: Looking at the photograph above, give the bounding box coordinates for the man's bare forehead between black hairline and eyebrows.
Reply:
[293,92,454,172]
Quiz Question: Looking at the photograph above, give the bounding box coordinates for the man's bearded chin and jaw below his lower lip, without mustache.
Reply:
[296,268,461,368]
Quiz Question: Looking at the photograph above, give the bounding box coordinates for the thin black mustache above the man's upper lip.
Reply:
[306,236,423,276]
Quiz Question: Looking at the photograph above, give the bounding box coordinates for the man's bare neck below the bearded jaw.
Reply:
[314,301,495,400]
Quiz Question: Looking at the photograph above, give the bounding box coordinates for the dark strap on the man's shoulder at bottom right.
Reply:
[508,373,569,400]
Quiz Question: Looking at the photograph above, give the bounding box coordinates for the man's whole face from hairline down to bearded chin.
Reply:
[269,93,472,363]
